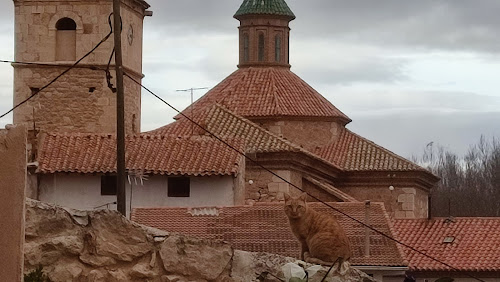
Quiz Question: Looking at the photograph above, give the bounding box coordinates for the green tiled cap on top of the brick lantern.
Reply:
[234,0,295,20]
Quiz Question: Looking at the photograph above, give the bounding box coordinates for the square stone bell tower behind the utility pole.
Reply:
[13,0,149,134]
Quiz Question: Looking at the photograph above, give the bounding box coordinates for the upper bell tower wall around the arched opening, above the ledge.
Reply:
[14,0,144,69]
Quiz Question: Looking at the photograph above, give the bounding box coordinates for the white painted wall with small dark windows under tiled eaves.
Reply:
[38,173,235,215]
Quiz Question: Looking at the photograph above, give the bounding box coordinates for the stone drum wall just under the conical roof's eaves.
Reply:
[255,120,341,152]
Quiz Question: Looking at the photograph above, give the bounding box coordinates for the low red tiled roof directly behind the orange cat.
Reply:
[132,203,406,266]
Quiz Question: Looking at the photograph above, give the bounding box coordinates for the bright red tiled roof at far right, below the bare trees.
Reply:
[394,217,500,271]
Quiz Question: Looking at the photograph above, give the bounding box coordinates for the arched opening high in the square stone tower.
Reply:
[56,18,76,61]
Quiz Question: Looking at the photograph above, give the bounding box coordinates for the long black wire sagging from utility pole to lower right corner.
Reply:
[124,73,485,282]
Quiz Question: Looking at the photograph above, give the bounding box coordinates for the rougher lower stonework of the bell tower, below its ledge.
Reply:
[14,66,141,133]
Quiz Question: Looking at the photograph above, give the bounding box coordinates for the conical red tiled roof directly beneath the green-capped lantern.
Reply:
[177,67,351,124]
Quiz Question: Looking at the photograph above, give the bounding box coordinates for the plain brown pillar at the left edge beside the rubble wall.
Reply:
[0,126,27,281]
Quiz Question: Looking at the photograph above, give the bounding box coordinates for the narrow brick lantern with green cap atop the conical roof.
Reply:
[234,0,295,68]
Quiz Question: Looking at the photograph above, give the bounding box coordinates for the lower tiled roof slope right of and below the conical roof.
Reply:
[314,128,427,171]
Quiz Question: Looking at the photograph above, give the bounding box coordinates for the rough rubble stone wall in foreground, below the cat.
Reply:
[24,199,375,282]
